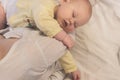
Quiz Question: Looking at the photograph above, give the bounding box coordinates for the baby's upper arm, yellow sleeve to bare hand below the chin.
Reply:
[31,8,74,48]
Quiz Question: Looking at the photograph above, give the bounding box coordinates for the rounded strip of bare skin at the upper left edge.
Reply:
[0,4,6,29]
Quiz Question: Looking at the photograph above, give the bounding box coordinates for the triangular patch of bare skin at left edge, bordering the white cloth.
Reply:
[0,36,18,60]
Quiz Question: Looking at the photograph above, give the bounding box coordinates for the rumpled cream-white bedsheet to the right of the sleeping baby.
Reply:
[71,0,120,80]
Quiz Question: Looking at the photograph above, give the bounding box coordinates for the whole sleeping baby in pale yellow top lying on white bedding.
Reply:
[1,0,91,80]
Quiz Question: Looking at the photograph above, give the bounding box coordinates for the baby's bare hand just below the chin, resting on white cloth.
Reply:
[62,35,74,49]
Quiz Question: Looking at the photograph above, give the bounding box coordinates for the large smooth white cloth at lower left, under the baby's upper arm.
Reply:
[0,28,66,80]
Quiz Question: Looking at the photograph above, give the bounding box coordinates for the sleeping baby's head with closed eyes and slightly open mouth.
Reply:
[55,0,91,32]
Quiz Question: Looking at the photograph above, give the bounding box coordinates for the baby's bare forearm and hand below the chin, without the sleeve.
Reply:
[54,30,74,49]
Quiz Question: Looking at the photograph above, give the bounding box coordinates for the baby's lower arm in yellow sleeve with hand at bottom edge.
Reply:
[59,50,80,80]
